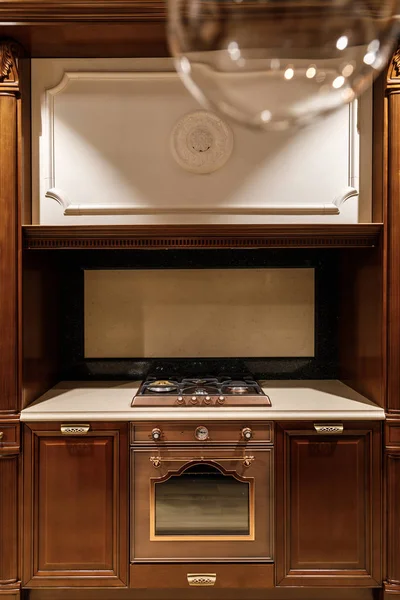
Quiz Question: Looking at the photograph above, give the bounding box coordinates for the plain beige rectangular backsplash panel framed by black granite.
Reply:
[84,268,315,358]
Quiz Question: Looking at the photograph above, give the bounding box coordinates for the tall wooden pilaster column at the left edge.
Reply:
[0,39,20,600]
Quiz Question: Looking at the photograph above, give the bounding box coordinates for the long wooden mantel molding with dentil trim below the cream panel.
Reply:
[23,223,382,250]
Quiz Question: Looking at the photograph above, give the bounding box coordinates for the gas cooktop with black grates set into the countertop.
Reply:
[131,375,271,408]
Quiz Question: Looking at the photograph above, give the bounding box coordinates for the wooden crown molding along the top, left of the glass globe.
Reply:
[0,0,166,23]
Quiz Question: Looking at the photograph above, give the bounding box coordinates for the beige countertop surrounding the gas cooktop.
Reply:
[21,380,385,422]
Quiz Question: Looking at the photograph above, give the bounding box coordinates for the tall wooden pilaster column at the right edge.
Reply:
[383,51,400,598]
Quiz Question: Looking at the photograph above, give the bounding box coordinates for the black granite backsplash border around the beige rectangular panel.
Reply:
[60,249,338,379]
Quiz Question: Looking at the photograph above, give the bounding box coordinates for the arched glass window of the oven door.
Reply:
[152,463,254,540]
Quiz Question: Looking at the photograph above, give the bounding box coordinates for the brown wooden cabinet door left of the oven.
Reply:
[23,423,128,587]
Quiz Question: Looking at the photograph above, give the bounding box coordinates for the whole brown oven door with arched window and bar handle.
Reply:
[131,446,273,562]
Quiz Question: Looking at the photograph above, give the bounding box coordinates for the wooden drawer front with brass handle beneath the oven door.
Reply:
[129,563,274,590]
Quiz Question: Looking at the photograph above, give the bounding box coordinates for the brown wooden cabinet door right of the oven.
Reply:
[276,422,382,587]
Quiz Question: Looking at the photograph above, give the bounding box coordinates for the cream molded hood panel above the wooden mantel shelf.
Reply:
[32,59,371,225]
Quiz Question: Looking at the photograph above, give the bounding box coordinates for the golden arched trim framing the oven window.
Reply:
[149,457,255,542]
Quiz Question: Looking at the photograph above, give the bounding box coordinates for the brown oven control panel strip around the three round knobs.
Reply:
[131,420,273,446]
